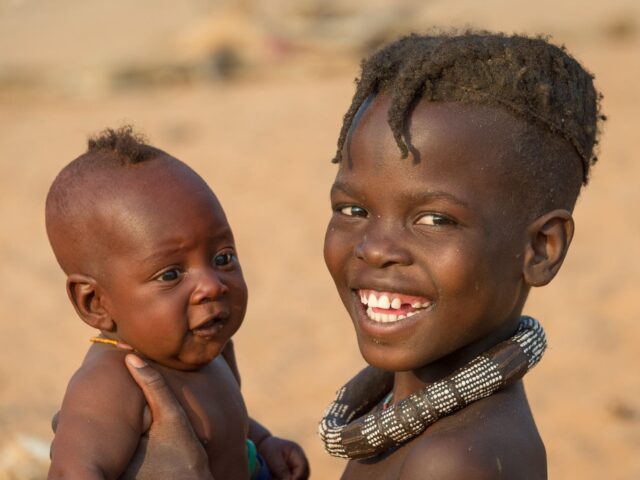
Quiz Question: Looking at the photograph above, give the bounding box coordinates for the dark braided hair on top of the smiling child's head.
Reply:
[333,32,604,184]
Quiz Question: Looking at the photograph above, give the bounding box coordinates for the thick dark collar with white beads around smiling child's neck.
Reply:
[319,317,547,459]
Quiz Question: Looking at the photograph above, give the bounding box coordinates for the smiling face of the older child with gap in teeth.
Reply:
[324,95,528,371]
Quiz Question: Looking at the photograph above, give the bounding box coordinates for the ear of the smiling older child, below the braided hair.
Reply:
[523,209,574,287]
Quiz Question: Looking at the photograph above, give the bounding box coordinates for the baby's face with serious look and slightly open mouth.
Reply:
[100,160,247,370]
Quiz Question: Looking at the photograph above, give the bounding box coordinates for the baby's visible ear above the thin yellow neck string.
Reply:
[67,273,116,331]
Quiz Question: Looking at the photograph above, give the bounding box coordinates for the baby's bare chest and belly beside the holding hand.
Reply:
[162,357,249,478]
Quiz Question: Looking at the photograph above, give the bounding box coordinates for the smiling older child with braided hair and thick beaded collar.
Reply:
[320,33,600,480]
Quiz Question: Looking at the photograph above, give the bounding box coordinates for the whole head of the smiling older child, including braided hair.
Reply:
[325,33,599,371]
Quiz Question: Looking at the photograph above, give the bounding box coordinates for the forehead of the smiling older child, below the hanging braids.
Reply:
[335,96,527,217]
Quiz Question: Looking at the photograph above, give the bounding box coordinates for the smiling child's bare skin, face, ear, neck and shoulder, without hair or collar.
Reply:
[324,95,573,479]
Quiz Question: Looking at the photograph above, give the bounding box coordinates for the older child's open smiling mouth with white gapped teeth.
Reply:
[357,290,433,323]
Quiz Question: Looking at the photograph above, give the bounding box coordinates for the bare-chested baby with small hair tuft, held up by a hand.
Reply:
[46,127,308,479]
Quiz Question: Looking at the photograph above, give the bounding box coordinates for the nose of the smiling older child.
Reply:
[354,222,411,268]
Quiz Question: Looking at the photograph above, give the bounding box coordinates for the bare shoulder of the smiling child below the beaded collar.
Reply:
[400,384,547,480]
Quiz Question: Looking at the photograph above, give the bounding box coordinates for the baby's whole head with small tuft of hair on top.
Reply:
[46,127,247,370]
